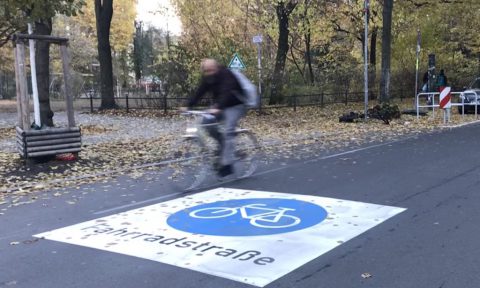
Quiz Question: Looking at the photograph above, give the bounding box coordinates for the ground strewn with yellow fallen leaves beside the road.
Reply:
[0,103,475,215]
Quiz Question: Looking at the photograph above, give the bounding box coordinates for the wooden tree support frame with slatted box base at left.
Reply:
[13,34,82,158]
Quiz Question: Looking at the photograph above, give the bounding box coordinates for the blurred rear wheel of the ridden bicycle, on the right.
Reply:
[235,130,260,178]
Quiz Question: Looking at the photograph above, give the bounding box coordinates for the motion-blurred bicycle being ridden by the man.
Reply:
[169,110,259,191]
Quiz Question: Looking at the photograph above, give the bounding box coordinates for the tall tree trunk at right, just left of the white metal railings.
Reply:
[380,0,393,102]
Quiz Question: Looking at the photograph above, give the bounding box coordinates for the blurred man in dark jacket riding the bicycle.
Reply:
[180,59,247,177]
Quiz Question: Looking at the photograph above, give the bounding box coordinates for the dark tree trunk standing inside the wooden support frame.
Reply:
[34,18,53,127]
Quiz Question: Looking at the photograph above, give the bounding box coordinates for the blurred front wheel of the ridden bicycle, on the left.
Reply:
[168,138,208,191]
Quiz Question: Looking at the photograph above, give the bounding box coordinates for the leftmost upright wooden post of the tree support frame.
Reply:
[16,43,30,131]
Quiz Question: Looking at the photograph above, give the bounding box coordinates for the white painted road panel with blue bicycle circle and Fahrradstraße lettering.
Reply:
[35,188,405,287]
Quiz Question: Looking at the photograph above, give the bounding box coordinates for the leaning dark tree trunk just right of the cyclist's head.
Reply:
[270,0,297,105]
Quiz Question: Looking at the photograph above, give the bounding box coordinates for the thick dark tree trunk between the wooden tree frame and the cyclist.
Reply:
[95,0,117,109]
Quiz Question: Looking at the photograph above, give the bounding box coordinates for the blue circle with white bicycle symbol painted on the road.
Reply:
[167,198,327,236]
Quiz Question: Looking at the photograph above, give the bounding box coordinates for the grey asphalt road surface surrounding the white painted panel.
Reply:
[0,125,480,288]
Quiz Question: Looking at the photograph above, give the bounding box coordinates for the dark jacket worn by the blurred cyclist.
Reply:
[188,67,242,109]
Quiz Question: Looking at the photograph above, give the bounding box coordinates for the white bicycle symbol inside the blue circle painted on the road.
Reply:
[189,203,301,228]
